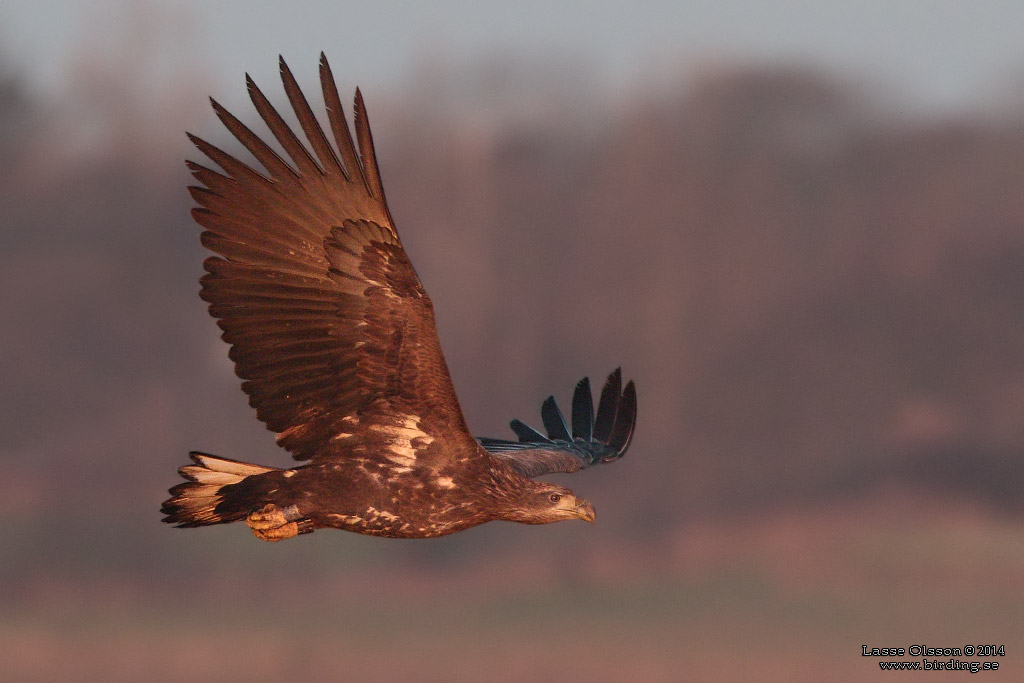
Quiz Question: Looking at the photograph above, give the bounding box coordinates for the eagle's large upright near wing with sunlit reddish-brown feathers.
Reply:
[187,54,476,460]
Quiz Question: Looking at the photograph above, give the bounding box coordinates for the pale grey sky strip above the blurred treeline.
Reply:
[6,0,1024,110]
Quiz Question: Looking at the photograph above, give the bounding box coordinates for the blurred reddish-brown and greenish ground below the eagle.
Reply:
[0,490,1024,683]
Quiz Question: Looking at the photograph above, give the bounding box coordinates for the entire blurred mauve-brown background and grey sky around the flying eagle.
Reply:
[0,0,1024,682]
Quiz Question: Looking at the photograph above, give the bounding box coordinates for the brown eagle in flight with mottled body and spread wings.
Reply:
[161,53,637,541]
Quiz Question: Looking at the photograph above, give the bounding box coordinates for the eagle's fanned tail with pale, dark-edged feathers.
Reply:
[160,451,280,526]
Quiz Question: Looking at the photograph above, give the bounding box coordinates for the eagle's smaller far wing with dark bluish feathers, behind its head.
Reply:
[477,369,637,477]
